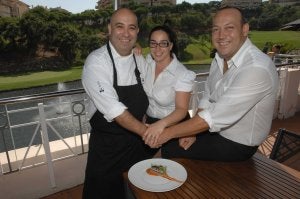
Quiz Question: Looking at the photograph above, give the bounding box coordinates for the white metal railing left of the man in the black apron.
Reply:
[0,89,90,176]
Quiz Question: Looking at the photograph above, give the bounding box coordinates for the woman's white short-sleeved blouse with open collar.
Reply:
[144,54,196,119]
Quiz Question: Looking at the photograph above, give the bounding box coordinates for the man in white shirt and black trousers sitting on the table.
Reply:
[146,7,278,161]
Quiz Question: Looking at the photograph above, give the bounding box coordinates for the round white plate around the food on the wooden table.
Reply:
[128,158,187,192]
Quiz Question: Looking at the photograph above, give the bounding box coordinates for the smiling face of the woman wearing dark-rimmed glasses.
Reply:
[150,30,173,65]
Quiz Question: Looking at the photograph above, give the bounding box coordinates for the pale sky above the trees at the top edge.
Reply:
[21,0,218,13]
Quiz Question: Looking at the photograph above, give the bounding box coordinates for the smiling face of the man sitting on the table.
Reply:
[212,8,249,61]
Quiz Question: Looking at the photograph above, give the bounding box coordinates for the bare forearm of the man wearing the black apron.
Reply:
[115,110,147,137]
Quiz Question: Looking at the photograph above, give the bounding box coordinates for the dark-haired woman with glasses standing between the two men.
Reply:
[143,26,196,148]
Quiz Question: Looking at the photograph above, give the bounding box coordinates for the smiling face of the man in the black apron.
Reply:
[108,8,139,56]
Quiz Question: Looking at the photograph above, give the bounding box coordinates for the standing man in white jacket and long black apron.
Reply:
[82,8,156,199]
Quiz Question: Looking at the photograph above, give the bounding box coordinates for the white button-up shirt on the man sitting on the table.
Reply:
[198,39,278,146]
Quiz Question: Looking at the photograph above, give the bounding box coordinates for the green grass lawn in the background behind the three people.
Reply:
[0,31,300,91]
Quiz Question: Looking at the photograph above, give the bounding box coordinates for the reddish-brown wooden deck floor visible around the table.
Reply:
[42,112,300,199]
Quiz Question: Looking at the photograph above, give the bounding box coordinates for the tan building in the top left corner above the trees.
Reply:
[0,0,29,17]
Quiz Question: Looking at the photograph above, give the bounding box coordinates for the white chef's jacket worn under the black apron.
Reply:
[82,43,145,121]
